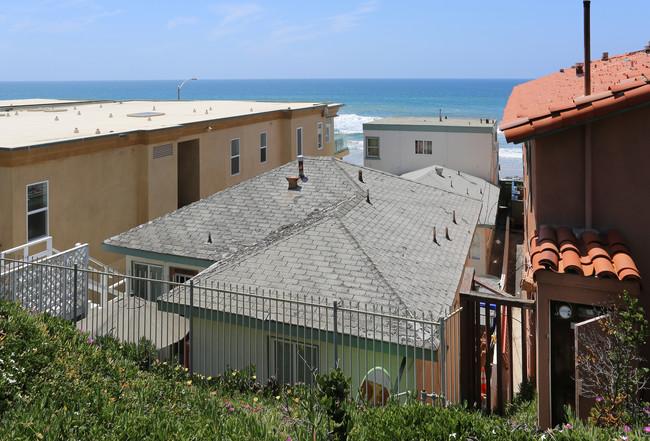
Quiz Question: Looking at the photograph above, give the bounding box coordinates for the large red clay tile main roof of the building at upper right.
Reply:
[499,51,650,142]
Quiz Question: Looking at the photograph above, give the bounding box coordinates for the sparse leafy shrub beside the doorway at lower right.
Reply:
[577,291,650,426]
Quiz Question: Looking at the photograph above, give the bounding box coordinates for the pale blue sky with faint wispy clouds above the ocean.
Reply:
[0,0,650,81]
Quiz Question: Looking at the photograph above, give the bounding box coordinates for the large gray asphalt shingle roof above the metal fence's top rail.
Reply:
[105,157,481,313]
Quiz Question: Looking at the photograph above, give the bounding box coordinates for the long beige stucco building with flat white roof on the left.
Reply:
[0,100,342,269]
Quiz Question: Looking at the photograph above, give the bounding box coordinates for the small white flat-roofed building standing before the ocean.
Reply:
[363,117,499,184]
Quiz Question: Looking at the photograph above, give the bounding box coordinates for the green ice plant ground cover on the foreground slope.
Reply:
[0,300,650,441]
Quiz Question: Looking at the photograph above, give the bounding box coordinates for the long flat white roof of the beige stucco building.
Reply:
[0,99,343,149]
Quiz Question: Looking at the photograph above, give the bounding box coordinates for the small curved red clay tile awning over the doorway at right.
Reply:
[530,226,641,281]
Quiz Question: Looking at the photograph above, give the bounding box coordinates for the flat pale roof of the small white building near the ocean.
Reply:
[363,115,497,132]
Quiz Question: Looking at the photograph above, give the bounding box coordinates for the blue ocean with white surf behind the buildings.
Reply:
[0,79,527,178]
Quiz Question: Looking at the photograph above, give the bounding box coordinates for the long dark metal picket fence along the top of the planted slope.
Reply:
[0,259,459,402]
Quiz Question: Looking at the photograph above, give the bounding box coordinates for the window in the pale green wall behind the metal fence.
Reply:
[269,337,319,385]
